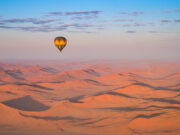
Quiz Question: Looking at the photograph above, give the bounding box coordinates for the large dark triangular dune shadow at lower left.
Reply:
[2,95,50,111]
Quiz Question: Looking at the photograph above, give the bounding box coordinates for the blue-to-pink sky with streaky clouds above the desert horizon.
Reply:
[0,0,180,60]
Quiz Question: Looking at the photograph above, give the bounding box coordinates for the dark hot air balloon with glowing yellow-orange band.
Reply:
[54,37,67,52]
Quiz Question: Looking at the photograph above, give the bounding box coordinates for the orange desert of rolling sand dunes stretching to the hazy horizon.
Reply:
[0,60,180,135]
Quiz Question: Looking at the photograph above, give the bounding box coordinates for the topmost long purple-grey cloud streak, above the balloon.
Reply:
[47,10,102,16]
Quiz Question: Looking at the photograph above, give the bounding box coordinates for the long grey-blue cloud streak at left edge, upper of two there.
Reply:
[2,18,60,24]
